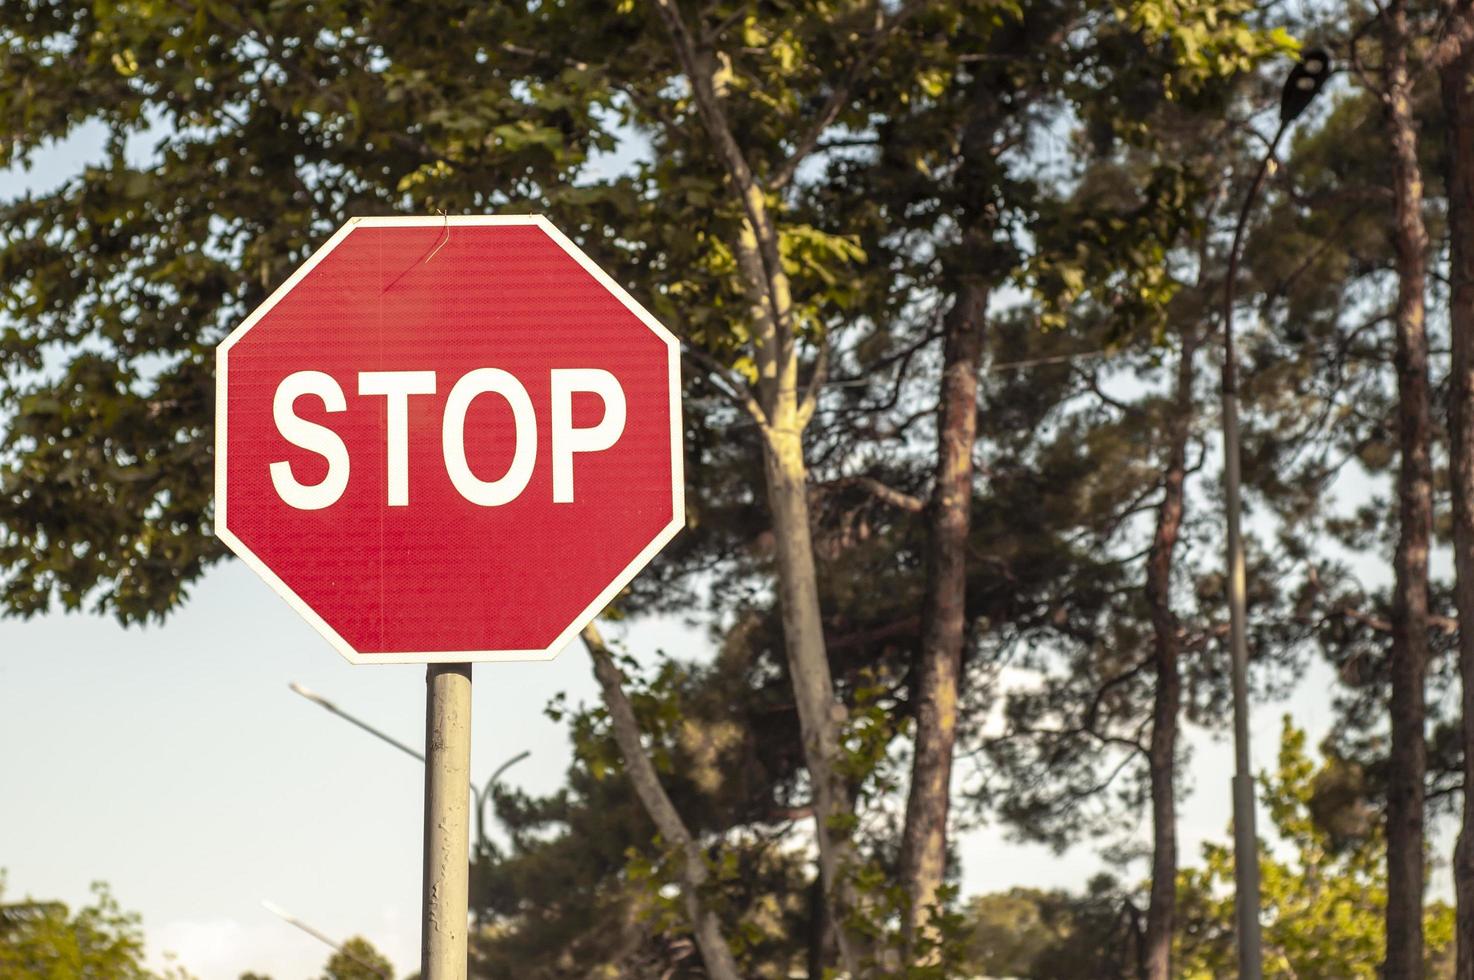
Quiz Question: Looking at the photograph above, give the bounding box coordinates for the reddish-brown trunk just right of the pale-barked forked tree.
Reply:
[901,280,988,959]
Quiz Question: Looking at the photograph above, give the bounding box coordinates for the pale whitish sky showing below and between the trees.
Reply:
[0,103,1450,980]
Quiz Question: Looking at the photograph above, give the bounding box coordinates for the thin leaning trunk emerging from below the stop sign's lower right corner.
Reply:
[582,623,741,980]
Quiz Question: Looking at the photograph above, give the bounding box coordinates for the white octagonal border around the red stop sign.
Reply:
[215,215,685,663]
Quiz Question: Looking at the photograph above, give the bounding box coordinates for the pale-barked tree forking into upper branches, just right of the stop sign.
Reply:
[636,0,914,974]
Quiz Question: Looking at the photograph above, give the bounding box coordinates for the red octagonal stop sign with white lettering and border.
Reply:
[215,215,684,663]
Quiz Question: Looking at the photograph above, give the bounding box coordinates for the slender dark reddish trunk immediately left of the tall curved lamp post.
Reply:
[1145,335,1197,980]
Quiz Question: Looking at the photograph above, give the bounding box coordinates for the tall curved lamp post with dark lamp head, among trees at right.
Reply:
[1222,49,1331,980]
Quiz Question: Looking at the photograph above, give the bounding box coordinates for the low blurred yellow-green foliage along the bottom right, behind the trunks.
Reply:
[964,716,1453,980]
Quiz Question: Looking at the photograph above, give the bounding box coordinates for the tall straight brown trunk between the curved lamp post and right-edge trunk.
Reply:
[1383,1,1433,980]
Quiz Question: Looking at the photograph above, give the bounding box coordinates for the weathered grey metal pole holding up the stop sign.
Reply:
[420,663,470,980]
